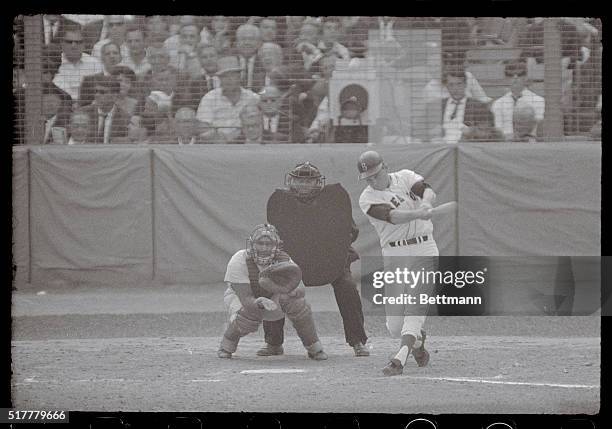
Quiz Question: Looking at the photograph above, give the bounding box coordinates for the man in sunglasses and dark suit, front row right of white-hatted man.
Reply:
[259,86,292,143]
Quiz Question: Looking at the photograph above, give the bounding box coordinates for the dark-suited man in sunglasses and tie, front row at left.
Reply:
[83,76,129,144]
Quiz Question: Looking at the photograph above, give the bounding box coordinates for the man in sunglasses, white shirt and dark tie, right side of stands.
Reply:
[491,61,545,140]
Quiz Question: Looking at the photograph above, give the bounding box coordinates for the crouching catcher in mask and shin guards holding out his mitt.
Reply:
[217,224,327,360]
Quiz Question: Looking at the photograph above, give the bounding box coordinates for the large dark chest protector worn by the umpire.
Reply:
[267,183,352,286]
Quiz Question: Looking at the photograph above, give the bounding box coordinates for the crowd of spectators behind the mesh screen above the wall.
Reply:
[13,15,601,145]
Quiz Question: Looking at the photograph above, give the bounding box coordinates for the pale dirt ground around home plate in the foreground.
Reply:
[12,288,601,414]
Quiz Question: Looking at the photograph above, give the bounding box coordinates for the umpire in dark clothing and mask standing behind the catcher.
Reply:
[257,162,370,356]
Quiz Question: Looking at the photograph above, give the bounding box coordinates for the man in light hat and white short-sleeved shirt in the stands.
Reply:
[196,56,259,142]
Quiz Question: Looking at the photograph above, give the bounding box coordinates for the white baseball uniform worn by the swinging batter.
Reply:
[359,170,439,338]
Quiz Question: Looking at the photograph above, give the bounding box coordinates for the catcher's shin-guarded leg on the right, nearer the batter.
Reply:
[279,295,327,360]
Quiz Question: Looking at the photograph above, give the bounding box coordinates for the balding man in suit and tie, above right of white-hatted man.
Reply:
[235,24,265,92]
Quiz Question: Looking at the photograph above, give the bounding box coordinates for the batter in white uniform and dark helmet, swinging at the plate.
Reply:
[357,151,439,375]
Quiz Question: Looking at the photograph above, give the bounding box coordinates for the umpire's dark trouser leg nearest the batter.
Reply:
[331,267,368,346]
